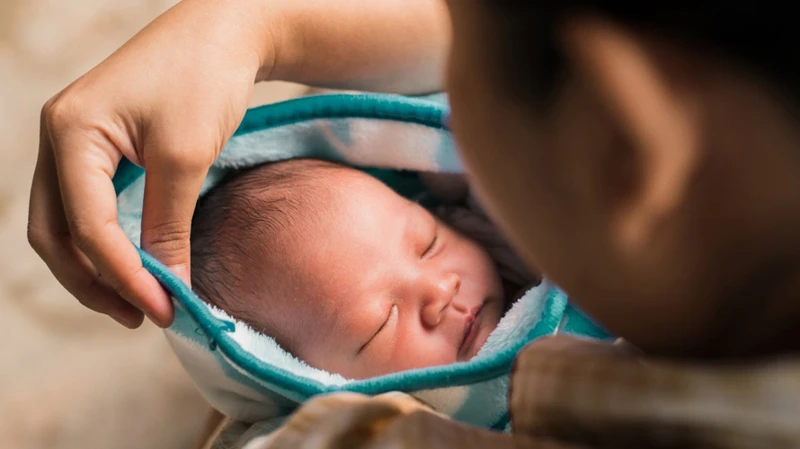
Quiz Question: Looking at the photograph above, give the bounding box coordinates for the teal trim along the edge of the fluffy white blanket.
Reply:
[113,94,607,429]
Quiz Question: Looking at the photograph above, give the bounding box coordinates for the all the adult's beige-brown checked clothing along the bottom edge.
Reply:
[203,336,800,449]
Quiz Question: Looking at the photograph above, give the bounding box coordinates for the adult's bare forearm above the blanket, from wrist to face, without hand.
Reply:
[258,0,450,93]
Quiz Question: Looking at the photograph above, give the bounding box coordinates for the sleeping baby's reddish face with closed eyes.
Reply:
[248,171,503,378]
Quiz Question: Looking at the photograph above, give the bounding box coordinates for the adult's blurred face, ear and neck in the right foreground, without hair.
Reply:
[447,0,800,357]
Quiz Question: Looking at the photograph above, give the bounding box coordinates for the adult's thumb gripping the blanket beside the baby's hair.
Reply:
[142,154,209,286]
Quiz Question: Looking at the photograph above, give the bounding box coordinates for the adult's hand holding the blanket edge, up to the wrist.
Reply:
[28,0,268,328]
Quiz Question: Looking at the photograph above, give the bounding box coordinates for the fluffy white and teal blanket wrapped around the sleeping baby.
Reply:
[114,94,608,429]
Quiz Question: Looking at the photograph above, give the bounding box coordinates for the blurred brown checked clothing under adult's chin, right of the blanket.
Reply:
[510,337,800,449]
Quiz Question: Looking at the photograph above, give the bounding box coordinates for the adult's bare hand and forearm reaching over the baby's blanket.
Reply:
[28,0,449,328]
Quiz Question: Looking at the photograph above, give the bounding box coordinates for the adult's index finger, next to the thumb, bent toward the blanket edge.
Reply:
[54,131,173,327]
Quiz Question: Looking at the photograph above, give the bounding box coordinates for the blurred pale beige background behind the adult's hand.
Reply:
[0,0,304,449]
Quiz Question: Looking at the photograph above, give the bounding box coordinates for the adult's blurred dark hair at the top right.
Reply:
[477,0,800,108]
